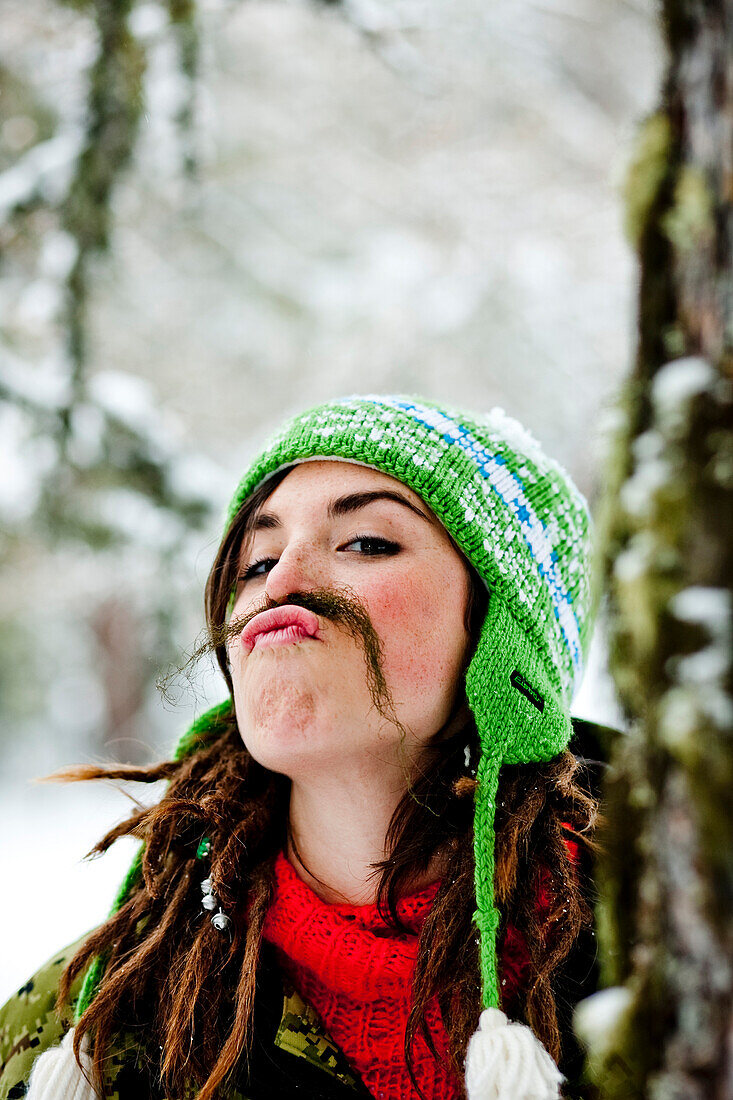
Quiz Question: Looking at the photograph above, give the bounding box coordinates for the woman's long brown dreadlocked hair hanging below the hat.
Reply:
[57,470,598,1100]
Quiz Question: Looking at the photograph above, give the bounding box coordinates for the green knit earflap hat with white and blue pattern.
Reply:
[77,394,591,1008]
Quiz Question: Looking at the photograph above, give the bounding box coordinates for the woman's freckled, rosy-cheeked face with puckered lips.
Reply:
[228,460,470,779]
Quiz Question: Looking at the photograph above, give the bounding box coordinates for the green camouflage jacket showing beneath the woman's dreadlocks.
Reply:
[0,937,370,1100]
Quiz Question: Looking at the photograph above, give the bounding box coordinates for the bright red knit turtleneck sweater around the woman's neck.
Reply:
[258,840,575,1100]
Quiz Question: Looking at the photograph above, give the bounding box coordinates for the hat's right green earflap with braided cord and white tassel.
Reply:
[466,593,571,1100]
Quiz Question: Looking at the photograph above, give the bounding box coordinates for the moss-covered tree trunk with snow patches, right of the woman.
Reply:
[578,0,733,1100]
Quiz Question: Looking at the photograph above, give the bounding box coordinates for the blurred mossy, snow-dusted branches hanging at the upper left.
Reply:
[0,0,208,546]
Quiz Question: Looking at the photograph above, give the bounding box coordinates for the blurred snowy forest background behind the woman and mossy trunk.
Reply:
[0,0,664,1002]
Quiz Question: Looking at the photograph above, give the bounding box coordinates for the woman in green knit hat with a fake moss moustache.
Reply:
[0,395,597,1100]
